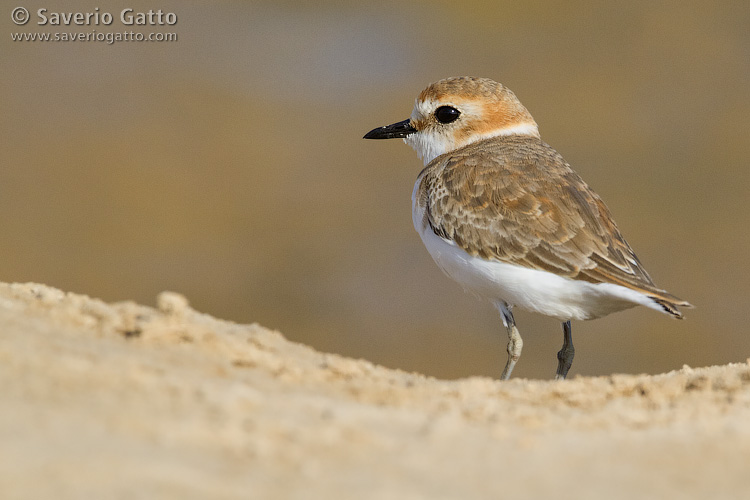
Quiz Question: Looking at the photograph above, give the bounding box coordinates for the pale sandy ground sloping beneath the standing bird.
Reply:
[0,284,750,499]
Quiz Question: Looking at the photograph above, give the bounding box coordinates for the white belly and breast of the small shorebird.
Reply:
[412,182,661,321]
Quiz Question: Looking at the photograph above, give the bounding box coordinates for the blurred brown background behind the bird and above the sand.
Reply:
[0,0,750,378]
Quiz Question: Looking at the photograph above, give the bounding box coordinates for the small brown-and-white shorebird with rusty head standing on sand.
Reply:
[364,77,692,379]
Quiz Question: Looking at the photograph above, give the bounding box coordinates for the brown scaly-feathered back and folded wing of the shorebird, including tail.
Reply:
[418,135,689,318]
